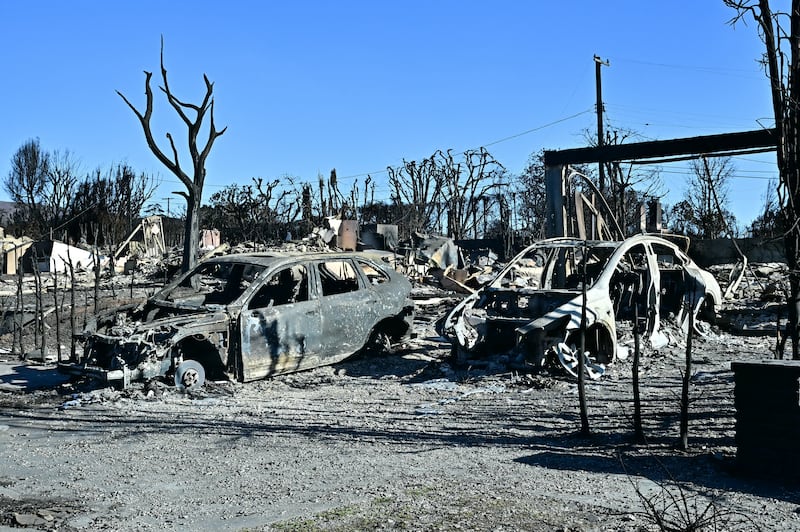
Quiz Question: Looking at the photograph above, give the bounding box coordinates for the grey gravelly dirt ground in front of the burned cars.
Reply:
[0,280,800,531]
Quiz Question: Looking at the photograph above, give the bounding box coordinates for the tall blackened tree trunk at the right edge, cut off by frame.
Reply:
[724,0,800,359]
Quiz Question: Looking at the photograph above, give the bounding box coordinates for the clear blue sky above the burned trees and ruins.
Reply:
[0,0,785,231]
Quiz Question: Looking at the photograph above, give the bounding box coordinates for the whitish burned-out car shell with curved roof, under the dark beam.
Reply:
[440,235,722,378]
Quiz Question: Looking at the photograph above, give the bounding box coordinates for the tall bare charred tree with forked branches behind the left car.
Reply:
[117,39,227,272]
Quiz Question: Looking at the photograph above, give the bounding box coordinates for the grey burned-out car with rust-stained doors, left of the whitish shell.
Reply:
[61,253,414,387]
